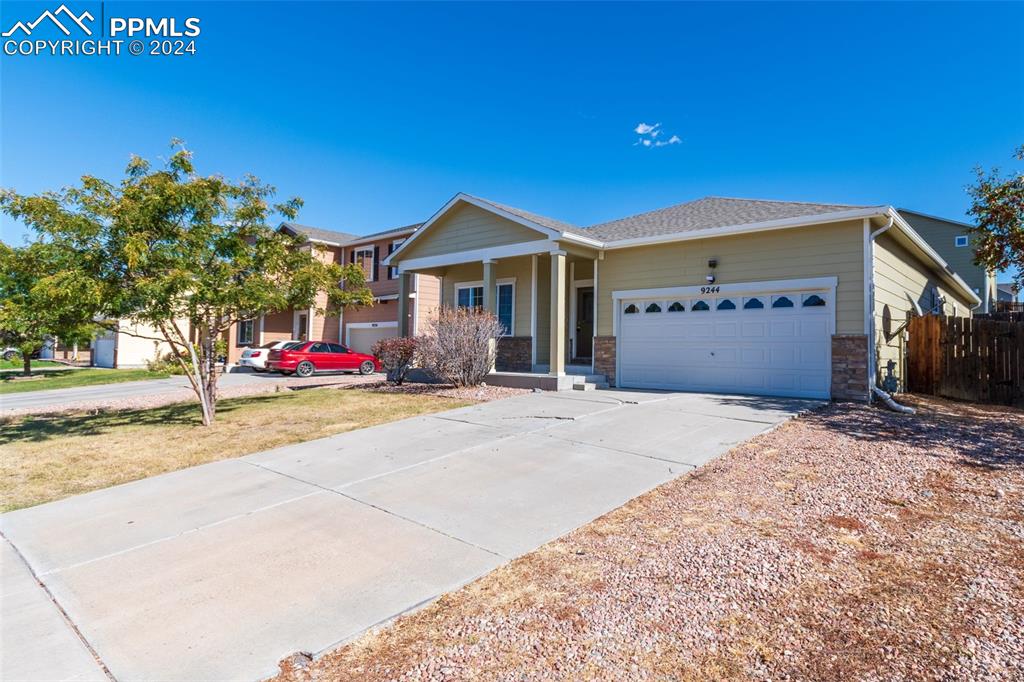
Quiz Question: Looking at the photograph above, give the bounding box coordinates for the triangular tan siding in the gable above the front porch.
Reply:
[402,204,546,259]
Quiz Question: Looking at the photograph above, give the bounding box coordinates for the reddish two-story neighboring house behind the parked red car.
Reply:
[227,222,440,365]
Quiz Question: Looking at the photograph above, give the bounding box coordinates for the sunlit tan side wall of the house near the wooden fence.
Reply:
[873,235,971,379]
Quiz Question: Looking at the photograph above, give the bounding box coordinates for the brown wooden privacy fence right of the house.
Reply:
[906,315,1024,404]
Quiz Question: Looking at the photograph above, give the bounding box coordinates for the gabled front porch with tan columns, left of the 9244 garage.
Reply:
[385,195,604,389]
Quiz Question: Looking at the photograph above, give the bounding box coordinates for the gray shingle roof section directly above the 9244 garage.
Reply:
[585,197,868,242]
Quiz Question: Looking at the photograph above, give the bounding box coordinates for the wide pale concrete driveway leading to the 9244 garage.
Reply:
[0,391,815,680]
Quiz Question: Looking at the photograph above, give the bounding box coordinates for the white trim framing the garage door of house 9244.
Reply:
[611,276,839,395]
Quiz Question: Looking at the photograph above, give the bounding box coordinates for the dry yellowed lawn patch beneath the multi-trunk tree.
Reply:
[0,388,468,511]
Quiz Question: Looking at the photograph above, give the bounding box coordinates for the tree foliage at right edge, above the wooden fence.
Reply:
[968,145,1024,287]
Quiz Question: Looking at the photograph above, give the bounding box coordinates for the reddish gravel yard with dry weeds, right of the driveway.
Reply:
[278,397,1024,681]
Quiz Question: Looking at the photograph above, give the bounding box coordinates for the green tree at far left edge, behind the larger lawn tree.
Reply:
[0,242,99,376]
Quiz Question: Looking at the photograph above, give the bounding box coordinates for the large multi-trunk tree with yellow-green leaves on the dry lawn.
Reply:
[0,140,373,425]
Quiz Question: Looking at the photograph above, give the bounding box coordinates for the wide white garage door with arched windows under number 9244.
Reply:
[616,285,835,398]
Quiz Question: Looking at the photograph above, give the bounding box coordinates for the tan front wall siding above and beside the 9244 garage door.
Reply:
[597,220,864,336]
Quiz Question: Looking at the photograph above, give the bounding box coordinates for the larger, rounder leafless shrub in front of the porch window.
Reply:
[418,308,503,386]
